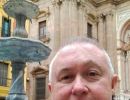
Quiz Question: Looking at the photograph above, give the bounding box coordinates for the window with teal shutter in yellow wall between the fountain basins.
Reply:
[1,17,11,37]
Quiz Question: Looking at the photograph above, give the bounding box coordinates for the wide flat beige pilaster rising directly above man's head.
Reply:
[60,0,78,45]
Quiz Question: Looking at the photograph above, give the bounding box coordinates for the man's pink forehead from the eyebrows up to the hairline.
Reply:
[53,43,107,70]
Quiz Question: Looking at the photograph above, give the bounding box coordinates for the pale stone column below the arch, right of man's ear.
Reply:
[117,50,129,93]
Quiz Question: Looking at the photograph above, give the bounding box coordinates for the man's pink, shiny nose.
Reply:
[72,77,89,96]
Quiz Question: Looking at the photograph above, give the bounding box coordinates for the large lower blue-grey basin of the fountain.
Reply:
[0,37,51,62]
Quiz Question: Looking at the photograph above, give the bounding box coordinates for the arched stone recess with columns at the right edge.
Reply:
[120,21,130,92]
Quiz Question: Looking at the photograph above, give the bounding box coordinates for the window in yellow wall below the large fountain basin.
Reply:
[0,62,8,86]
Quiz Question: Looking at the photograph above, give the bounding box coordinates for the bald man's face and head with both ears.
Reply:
[49,44,117,100]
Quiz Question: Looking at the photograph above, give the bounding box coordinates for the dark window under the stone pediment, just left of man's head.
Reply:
[36,77,46,100]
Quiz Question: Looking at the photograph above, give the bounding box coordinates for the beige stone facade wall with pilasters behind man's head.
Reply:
[29,0,130,100]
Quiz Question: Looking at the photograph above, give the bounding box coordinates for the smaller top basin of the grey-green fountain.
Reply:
[3,0,39,19]
